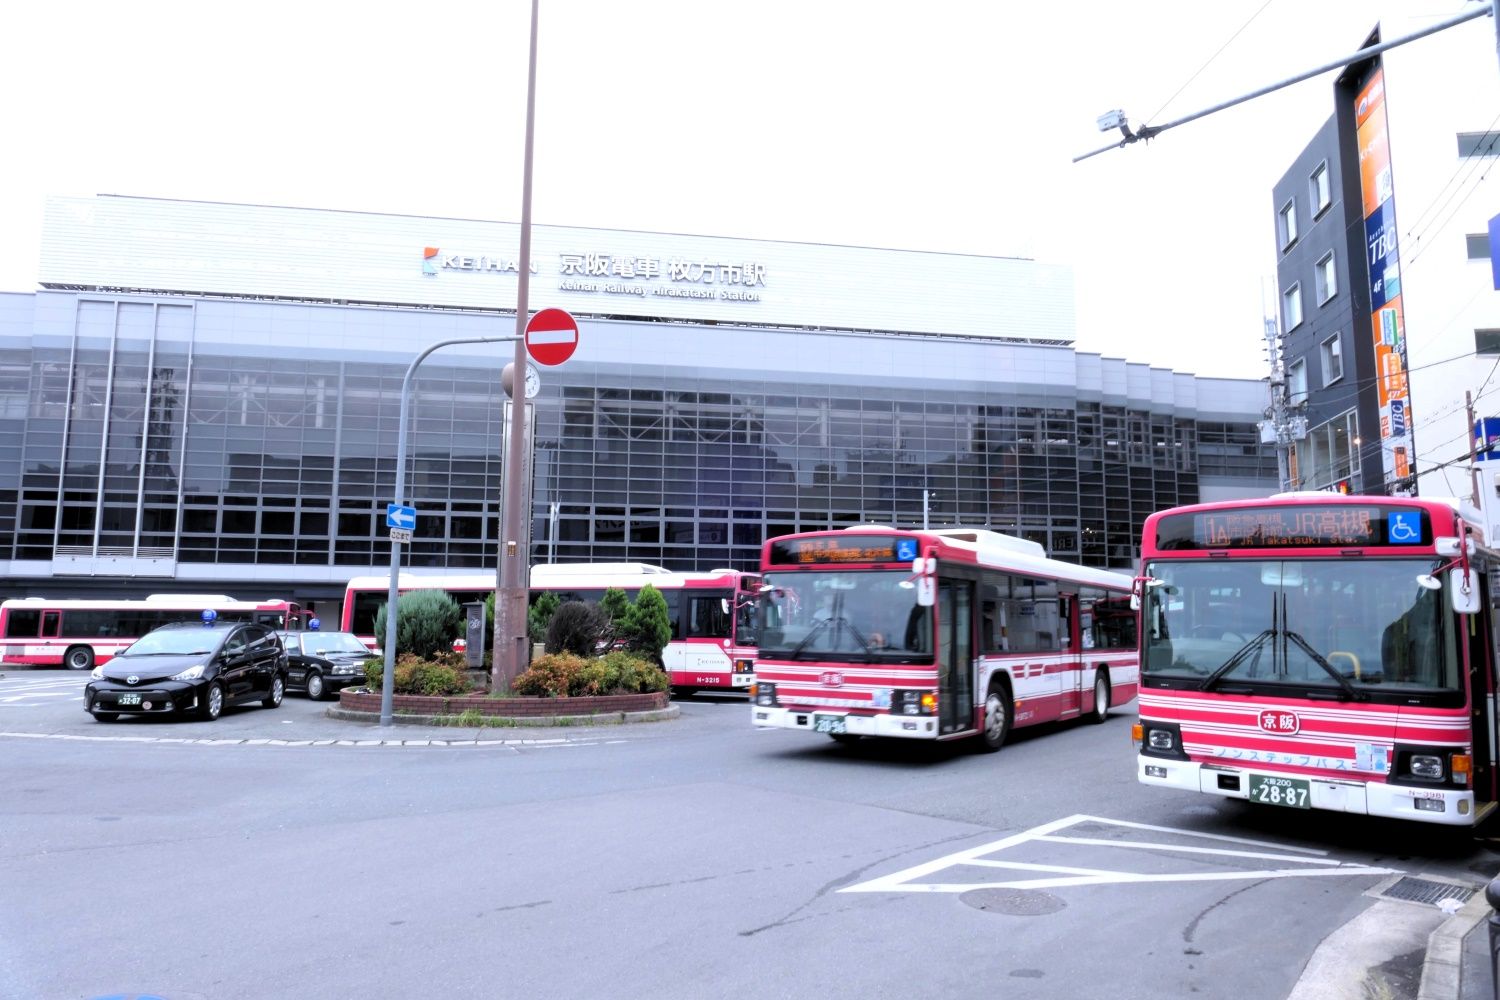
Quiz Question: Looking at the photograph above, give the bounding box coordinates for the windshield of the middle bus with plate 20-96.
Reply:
[758,570,932,663]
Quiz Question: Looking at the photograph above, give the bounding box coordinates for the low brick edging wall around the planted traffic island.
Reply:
[327,688,678,727]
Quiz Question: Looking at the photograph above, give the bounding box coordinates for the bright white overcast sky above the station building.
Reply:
[0,0,1476,378]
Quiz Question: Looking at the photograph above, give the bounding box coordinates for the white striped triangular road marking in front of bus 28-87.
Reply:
[839,814,1401,892]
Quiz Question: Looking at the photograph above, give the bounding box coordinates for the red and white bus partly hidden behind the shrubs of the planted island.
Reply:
[342,562,756,693]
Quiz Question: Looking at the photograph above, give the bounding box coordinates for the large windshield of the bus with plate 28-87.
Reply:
[1142,558,1463,699]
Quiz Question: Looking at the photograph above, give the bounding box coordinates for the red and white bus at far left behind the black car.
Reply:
[0,594,302,670]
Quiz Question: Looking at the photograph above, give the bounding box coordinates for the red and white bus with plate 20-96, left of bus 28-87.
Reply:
[750,526,1139,751]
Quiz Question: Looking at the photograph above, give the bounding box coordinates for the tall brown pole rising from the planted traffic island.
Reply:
[489,0,540,691]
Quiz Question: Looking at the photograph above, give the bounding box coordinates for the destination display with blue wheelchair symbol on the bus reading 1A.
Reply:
[1157,504,1433,550]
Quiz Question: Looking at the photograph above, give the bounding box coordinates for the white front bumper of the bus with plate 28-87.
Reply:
[1136,754,1476,826]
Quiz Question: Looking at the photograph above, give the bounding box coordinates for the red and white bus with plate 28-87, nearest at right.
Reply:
[1136,493,1496,826]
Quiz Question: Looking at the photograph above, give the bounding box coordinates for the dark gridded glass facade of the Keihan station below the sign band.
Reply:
[0,295,1277,598]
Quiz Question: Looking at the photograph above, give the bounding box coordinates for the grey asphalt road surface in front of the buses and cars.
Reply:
[0,672,1500,1000]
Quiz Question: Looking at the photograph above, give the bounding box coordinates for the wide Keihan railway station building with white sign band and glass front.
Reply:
[0,196,1277,606]
